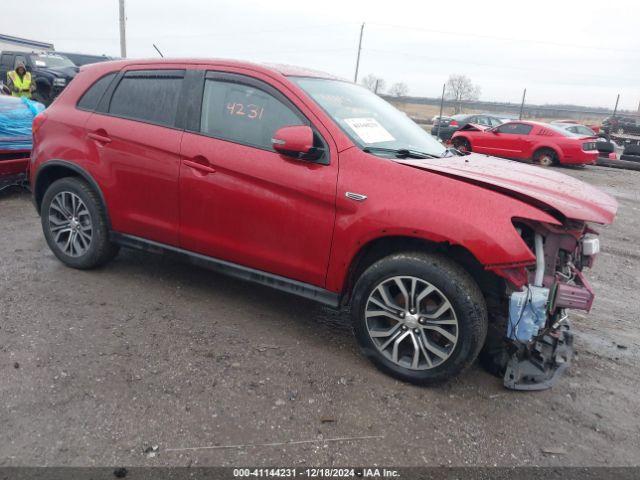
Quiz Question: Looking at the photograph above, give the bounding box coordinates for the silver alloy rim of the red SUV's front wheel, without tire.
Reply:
[365,276,459,370]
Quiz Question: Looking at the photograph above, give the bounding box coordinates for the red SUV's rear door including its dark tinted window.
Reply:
[86,66,184,246]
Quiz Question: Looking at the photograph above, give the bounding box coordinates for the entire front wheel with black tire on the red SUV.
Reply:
[351,252,487,385]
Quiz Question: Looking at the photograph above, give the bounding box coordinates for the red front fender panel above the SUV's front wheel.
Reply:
[326,151,558,292]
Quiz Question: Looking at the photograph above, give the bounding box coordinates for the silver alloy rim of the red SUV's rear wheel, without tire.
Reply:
[49,191,93,257]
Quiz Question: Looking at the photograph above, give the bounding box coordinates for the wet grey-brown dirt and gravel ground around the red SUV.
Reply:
[0,167,640,466]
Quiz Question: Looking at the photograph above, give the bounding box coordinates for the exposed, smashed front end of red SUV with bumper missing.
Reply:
[492,220,600,390]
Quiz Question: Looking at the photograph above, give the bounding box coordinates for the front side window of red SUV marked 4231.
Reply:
[200,79,306,151]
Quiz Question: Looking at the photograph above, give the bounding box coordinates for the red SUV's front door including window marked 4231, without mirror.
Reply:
[180,72,338,286]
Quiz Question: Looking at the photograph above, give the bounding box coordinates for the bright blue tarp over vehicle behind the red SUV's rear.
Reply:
[0,95,44,151]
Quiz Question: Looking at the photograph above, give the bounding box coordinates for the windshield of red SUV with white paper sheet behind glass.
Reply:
[292,77,447,157]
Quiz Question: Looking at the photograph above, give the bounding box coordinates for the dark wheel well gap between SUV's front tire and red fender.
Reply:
[341,236,505,305]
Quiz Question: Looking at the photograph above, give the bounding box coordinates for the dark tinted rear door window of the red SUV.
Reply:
[109,70,184,127]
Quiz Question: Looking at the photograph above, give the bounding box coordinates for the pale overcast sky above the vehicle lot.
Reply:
[0,0,640,110]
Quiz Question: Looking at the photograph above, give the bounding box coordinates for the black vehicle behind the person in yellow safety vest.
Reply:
[0,50,78,105]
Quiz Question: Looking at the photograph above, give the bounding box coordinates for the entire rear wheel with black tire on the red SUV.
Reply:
[40,177,118,270]
